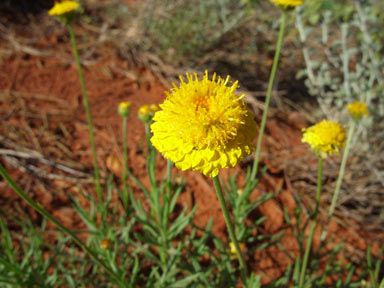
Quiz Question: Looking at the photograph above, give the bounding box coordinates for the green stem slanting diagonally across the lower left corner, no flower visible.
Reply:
[0,164,126,287]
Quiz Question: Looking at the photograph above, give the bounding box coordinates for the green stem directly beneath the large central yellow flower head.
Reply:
[212,176,248,285]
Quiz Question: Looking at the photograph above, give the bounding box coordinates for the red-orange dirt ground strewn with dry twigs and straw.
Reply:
[0,2,383,283]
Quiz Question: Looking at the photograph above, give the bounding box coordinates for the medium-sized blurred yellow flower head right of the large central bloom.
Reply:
[301,120,346,158]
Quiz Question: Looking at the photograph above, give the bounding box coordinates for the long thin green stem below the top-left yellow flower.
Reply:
[67,23,103,202]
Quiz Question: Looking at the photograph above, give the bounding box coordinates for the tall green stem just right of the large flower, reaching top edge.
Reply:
[250,10,287,180]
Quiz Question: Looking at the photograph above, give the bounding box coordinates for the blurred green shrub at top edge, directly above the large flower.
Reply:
[139,0,247,64]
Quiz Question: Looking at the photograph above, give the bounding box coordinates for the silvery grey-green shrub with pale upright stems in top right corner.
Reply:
[296,0,384,130]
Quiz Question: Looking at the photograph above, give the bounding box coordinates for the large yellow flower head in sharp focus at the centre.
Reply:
[151,72,257,177]
